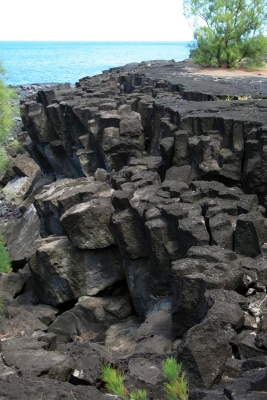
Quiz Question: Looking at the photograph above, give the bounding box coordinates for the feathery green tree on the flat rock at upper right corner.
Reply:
[184,0,267,68]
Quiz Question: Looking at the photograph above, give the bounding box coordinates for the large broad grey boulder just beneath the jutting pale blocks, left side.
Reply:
[29,237,125,306]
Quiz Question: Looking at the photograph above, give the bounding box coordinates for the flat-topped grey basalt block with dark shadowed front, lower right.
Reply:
[172,246,243,336]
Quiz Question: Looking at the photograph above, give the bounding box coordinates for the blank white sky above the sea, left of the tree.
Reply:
[0,0,193,41]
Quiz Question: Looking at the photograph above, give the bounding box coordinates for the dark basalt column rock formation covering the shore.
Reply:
[0,61,267,400]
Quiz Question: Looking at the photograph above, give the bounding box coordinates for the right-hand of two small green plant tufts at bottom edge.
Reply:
[162,357,189,400]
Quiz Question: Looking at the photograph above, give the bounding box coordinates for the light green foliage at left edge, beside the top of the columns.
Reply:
[0,61,16,173]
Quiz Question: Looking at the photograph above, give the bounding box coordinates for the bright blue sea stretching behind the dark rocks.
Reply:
[0,42,192,85]
